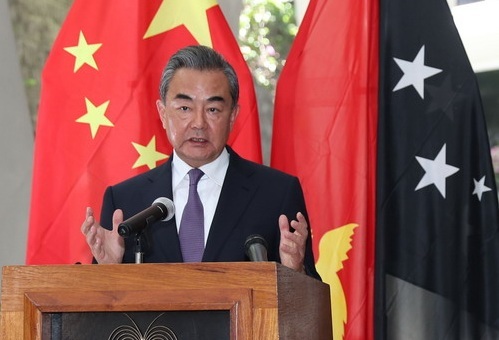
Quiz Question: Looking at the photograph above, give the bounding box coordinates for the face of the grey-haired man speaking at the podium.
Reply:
[156,68,239,168]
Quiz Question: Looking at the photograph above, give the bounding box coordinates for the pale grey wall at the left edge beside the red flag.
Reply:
[0,0,33,266]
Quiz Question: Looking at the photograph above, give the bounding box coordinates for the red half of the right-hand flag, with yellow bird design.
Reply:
[271,0,378,340]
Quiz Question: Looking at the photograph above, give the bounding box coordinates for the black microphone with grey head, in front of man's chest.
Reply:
[118,197,175,237]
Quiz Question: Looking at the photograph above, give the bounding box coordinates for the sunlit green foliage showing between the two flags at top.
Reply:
[239,0,298,91]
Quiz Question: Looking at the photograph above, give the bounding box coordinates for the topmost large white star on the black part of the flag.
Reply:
[393,45,442,99]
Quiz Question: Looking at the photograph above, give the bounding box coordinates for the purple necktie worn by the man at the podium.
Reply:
[179,169,204,262]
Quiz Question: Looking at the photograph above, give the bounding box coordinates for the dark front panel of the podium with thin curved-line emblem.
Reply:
[42,310,230,340]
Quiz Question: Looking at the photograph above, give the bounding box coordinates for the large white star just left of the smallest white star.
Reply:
[414,144,459,198]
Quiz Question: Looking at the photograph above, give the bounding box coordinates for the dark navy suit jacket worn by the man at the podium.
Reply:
[100,147,320,279]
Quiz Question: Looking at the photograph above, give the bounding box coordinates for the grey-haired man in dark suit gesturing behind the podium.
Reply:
[81,46,320,279]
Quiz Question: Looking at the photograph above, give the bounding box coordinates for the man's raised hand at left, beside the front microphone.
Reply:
[81,207,125,263]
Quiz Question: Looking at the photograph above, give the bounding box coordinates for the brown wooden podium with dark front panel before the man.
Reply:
[0,262,332,340]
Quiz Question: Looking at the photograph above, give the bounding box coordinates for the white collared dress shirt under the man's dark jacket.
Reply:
[172,148,230,245]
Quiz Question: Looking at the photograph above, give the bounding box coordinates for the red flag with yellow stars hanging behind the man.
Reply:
[26,0,261,264]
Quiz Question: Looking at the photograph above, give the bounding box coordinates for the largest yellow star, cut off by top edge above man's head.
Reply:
[144,0,217,47]
